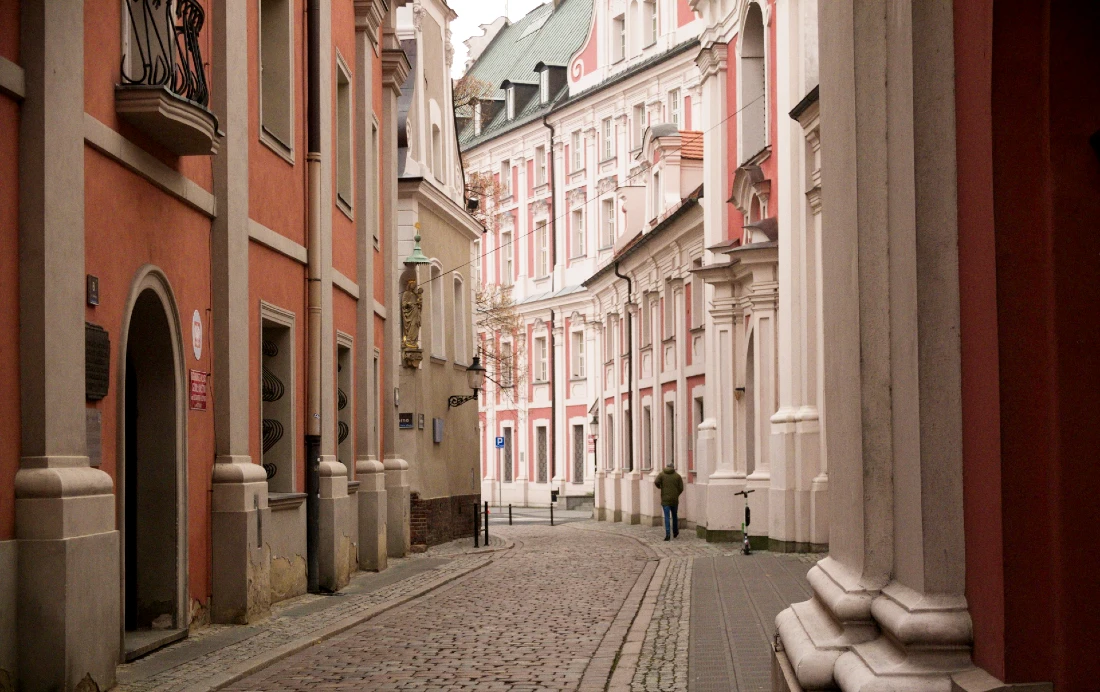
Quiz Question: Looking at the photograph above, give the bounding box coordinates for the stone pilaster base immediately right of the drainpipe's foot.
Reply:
[317,457,351,592]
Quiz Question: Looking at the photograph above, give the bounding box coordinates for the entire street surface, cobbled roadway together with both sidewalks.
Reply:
[119,520,821,692]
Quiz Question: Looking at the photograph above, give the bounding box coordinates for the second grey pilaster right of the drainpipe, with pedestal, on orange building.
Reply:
[353,0,389,571]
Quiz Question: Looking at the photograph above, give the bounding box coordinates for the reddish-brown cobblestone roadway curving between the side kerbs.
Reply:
[226,525,651,692]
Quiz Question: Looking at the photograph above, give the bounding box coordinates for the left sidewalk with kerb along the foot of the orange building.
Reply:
[113,534,512,692]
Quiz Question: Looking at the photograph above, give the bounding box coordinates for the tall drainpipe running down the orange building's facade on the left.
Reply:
[306,0,321,593]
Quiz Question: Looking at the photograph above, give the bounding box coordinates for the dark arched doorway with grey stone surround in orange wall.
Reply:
[118,273,189,660]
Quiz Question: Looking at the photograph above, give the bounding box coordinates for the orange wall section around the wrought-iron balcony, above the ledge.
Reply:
[82,0,213,191]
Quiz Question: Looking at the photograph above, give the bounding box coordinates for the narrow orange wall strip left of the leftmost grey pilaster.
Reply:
[0,92,20,540]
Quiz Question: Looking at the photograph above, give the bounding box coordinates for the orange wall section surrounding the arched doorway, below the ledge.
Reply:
[84,149,217,601]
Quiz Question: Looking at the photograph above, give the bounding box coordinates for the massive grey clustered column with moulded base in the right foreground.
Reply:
[777,0,970,692]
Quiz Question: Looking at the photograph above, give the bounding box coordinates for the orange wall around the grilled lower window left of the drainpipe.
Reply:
[246,243,307,492]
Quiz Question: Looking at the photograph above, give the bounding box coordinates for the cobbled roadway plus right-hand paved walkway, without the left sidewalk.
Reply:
[171,519,813,691]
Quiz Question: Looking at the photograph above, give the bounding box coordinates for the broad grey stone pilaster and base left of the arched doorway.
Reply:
[13,0,121,690]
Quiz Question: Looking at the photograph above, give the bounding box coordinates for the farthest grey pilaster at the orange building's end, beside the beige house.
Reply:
[382,32,411,558]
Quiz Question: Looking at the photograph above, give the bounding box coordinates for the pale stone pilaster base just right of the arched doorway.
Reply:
[210,457,272,625]
